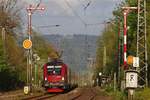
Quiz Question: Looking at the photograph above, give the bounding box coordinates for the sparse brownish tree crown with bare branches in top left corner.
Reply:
[0,0,21,29]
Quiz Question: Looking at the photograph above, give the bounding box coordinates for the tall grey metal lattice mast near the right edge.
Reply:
[137,0,148,86]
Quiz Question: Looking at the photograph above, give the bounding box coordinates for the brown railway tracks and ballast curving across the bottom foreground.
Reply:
[0,87,113,100]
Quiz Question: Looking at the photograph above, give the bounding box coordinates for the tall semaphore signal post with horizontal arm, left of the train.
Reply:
[27,3,45,92]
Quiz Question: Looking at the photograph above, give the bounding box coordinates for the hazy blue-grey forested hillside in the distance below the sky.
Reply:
[44,34,98,72]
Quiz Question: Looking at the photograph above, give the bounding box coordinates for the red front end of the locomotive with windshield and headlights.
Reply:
[44,61,67,92]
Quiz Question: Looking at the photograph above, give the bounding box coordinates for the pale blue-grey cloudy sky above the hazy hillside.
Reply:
[22,0,121,35]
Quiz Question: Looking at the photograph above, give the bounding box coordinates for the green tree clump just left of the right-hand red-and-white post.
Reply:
[97,24,118,75]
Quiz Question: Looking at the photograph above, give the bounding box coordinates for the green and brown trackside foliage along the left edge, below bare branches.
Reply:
[0,35,25,90]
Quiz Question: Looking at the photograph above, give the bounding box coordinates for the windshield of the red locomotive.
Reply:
[47,66,61,75]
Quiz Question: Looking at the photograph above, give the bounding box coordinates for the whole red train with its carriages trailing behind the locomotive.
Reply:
[43,59,77,93]
